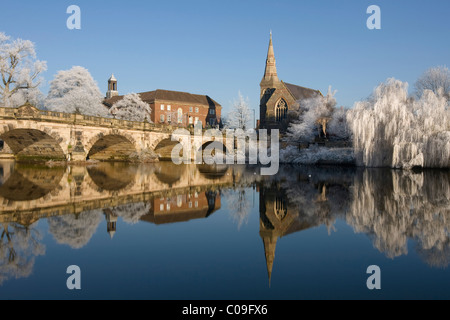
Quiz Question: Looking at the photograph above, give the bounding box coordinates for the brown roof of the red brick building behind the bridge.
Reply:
[104,89,221,107]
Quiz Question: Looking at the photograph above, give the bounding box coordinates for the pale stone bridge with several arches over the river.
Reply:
[0,104,234,161]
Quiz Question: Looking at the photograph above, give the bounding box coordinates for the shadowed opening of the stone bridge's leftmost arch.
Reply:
[0,125,66,160]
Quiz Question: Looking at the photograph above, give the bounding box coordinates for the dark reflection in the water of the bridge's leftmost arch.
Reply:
[0,165,66,201]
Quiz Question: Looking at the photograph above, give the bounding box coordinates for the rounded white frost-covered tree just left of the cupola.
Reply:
[46,66,109,117]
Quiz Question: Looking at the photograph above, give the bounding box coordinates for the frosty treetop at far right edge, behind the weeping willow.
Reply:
[415,66,450,99]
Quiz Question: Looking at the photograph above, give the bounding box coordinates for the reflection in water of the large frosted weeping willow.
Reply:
[347,170,450,266]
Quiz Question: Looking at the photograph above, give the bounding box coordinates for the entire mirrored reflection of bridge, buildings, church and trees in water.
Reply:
[0,162,450,290]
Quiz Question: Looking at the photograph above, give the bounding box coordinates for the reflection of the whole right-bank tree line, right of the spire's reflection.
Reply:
[260,166,450,267]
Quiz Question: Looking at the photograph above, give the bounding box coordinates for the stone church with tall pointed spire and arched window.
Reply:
[259,32,322,132]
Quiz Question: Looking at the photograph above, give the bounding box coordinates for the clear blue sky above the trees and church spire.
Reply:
[0,0,450,113]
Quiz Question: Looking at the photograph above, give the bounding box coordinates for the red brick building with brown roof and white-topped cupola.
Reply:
[104,76,222,128]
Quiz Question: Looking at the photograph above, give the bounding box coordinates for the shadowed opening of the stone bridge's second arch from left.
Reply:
[86,133,136,161]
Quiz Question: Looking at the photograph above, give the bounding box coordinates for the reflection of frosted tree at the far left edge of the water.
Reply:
[0,223,45,285]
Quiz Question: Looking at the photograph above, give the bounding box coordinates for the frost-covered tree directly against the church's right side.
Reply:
[287,87,336,142]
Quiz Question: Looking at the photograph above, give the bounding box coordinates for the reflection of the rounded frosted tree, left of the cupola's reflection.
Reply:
[48,210,103,249]
